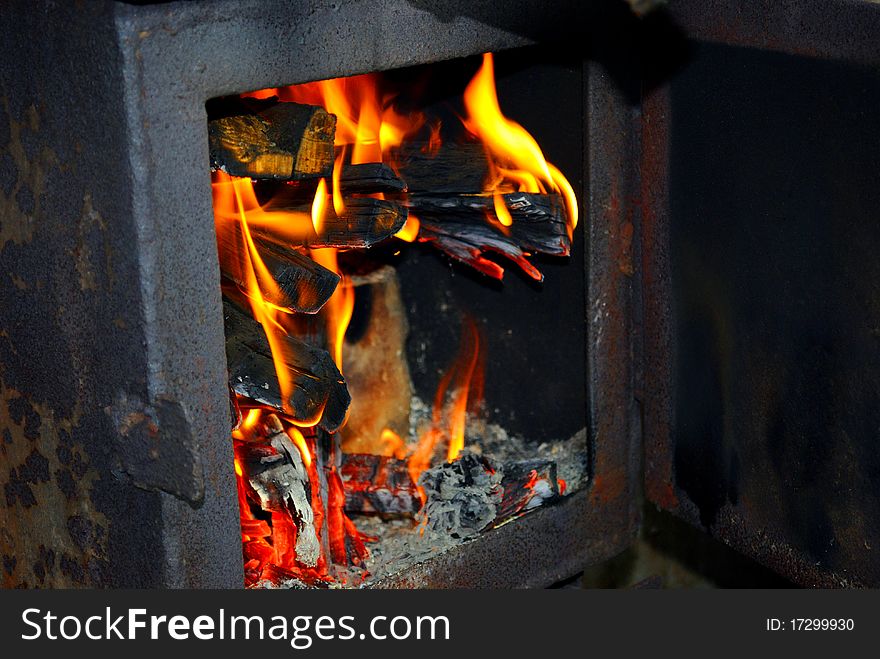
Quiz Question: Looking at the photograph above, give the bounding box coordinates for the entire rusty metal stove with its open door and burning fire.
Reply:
[0,0,880,588]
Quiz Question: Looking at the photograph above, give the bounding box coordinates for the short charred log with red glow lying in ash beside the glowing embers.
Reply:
[340,453,421,515]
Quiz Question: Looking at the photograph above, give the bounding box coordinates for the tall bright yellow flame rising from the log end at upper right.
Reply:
[464,53,578,231]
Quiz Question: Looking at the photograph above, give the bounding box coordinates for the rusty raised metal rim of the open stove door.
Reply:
[640,0,880,587]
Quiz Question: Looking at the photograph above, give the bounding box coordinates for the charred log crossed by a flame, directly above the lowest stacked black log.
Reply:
[217,224,340,314]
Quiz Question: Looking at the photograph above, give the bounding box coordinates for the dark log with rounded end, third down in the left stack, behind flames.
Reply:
[252,196,407,248]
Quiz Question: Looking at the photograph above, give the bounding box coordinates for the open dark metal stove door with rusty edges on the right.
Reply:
[641,2,880,587]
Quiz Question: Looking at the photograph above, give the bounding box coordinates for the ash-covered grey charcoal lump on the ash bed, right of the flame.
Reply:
[419,450,502,538]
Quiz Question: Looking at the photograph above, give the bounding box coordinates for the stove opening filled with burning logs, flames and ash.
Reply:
[207,49,590,587]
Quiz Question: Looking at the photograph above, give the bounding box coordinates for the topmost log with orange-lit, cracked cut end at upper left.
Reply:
[208,98,336,179]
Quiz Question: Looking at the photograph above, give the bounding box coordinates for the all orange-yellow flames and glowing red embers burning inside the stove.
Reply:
[212,53,577,584]
